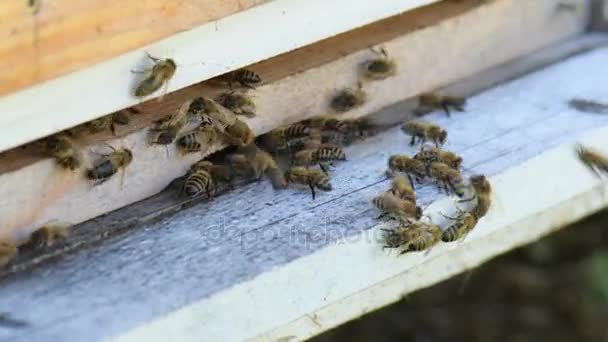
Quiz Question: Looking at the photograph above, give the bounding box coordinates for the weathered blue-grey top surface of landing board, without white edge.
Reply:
[0,44,608,340]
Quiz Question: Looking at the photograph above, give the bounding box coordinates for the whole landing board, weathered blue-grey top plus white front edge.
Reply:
[0,48,608,341]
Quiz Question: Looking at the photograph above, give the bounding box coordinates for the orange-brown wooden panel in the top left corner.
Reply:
[0,0,265,95]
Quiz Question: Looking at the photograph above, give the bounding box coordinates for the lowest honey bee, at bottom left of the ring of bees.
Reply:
[384,220,443,254]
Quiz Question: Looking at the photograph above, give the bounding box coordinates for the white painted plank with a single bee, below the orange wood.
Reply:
[0,0,438,152]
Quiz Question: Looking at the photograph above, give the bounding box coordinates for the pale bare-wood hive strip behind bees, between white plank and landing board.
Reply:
[0,0,585,243]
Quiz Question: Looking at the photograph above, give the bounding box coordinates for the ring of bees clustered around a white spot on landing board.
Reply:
[372,117,492,254]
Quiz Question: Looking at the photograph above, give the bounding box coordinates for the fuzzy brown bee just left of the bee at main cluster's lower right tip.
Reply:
[229,145,287,189]
